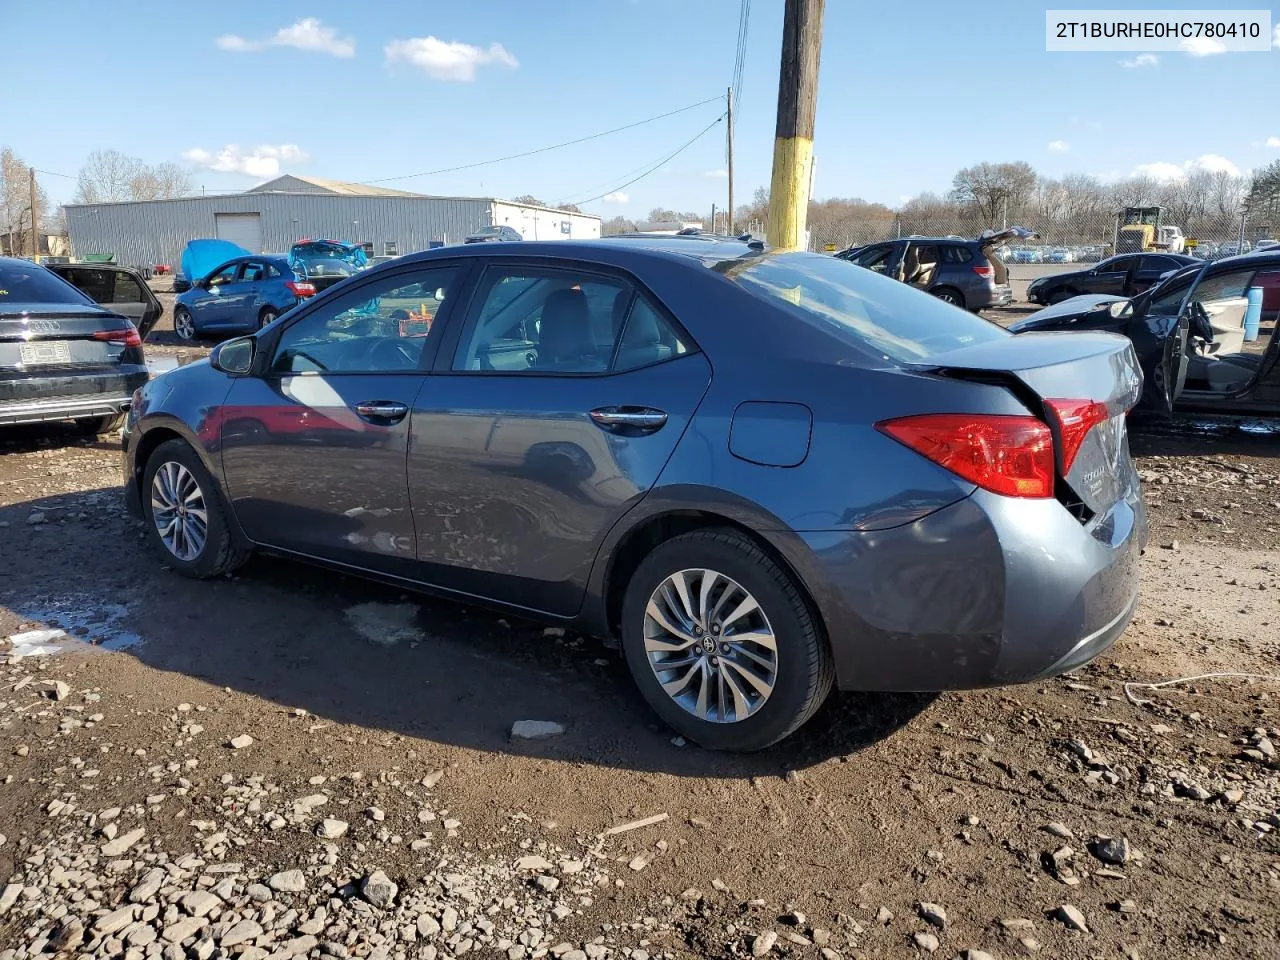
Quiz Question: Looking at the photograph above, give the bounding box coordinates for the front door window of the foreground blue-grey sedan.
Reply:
[271,266,458,374]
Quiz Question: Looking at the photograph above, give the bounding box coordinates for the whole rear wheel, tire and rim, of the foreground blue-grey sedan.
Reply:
[622,529,835,751]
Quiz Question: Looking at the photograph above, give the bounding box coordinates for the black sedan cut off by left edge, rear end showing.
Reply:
[0,257,154,434]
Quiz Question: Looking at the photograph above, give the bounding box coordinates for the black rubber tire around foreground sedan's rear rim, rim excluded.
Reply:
[622,527,835,753]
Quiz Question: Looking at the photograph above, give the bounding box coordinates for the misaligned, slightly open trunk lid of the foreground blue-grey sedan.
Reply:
[906,333,1142,516]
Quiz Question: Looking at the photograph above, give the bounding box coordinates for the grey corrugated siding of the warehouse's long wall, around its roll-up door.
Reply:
[65,193,494,269]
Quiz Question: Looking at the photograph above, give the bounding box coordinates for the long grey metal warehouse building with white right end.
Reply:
[64,175,600,268]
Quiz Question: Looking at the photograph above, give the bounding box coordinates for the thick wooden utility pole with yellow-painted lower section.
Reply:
[768,0,824,250]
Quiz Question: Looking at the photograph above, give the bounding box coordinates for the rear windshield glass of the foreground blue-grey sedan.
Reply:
[724,253,1012,362]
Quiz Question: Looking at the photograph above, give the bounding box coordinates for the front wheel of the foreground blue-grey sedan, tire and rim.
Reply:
[142,440,248,580]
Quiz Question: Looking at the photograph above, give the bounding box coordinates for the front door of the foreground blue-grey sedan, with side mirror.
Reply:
[220,262,465,576]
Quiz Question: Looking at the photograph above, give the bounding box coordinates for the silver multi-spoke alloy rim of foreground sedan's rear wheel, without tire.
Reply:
[644,568,778,723]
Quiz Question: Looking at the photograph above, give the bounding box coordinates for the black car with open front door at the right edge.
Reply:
[1009,251,1280,415]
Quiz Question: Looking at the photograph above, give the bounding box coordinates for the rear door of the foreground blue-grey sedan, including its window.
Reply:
[408,257,710,616]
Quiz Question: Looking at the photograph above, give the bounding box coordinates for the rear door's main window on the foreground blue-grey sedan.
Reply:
[453,268,631,374]
